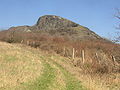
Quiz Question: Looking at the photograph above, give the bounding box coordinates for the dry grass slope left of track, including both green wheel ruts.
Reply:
[0,42,85,90]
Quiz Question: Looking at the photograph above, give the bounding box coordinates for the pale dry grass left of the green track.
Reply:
[0,42,42,89]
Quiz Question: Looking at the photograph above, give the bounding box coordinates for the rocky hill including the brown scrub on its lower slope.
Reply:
[0,15,120,73]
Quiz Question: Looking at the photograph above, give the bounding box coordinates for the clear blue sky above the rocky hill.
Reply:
[0,0,120,37]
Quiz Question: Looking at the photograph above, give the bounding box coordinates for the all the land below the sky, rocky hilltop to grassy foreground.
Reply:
[0,15,120,90]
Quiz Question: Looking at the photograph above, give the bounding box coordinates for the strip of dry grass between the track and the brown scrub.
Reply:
[47,54,120,90]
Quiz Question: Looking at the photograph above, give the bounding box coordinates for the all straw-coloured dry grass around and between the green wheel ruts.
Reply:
[0,42,120,90]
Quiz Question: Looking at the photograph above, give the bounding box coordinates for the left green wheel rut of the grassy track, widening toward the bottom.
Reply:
[19,62,56,90]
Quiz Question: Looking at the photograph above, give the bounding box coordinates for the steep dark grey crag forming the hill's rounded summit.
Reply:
[36,15,79,30]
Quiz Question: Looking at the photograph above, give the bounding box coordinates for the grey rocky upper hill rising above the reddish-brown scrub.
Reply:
[8,15,102,40]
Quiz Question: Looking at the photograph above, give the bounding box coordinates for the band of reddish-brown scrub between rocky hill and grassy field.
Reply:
[0,31,120,74]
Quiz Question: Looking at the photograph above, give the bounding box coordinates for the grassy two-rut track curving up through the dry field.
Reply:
[19,55,86,90]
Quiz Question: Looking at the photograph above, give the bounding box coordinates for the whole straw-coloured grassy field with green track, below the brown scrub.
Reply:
[0,42,120,90]
